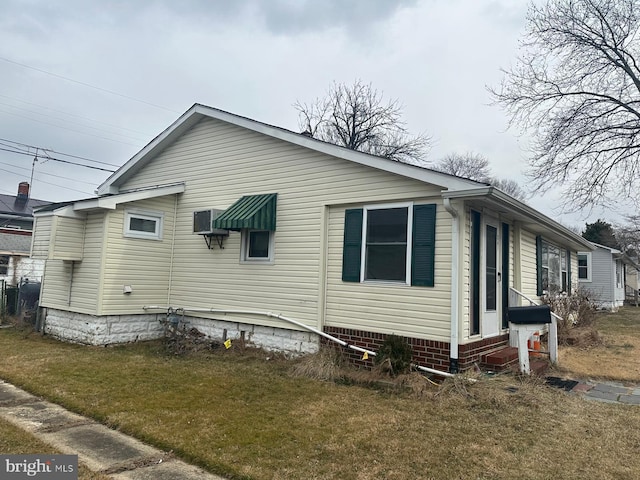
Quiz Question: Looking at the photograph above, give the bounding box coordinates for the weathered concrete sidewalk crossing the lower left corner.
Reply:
[0,380,223,480]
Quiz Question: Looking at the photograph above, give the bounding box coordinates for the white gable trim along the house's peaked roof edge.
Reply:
[97,103,486,195]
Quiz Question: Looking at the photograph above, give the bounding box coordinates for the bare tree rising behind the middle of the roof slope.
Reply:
[294,81,430,163]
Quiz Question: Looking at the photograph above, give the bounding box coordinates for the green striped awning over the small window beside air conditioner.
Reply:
[213,193,278,231]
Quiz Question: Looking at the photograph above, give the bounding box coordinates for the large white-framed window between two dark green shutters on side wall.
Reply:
[360,203,413,285]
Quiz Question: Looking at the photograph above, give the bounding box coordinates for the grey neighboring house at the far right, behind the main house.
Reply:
[578,243,638,310]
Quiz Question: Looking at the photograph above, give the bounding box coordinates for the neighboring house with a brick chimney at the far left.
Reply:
[0,182,49,285]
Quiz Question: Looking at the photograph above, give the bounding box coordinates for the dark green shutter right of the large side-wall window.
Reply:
[411,204,436,287]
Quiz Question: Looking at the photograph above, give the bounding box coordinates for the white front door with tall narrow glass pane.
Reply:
[480,217,502,338]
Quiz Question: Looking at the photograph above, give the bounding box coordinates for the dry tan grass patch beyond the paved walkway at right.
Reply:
[559,307,640,384]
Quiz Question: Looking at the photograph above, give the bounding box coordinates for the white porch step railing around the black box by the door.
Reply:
[509,287,562,375]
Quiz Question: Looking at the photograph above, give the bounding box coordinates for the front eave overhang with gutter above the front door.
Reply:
[442,186,595,251]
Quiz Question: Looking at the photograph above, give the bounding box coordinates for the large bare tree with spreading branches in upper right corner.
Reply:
[490,0,640,210]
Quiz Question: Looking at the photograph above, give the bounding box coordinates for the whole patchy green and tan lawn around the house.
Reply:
[0,309,640,480]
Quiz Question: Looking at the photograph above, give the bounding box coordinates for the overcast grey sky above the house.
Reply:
[0,0,619,227]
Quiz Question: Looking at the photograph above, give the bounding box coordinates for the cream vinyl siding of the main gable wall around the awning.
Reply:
[115,119,450,334]
